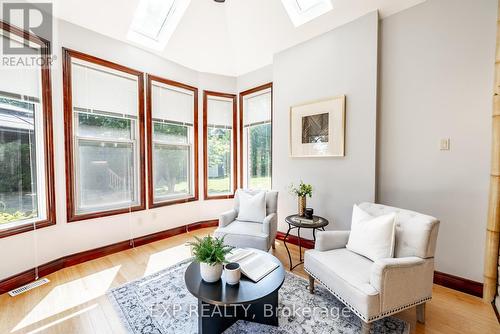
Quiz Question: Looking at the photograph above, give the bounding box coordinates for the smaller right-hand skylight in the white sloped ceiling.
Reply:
[281,0,333,27]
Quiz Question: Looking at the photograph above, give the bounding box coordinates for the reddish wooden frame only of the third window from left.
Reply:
[146,74,199,209]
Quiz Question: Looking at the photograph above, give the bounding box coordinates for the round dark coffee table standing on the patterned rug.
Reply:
[184,250,285,334]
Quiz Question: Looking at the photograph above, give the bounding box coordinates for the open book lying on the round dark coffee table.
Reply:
[226,248,279,282]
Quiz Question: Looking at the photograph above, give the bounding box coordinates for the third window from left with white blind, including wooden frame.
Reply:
[147,75,198,208]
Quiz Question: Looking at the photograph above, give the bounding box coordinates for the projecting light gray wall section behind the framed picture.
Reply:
[273,12,378,237]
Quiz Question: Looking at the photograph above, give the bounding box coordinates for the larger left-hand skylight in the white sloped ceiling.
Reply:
[127,0,191,50]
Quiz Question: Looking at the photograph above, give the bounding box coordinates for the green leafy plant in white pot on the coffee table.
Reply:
[188,235,234,283]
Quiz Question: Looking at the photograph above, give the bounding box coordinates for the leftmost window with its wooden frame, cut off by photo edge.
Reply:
[0,22,55,237]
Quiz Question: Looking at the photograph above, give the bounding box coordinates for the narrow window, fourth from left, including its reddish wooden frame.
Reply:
[203,91,238,199]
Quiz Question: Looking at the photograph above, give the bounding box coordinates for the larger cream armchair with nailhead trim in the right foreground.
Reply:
[304,203,439,334]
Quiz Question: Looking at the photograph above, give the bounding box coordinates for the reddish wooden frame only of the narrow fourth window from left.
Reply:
[203,90,238,200]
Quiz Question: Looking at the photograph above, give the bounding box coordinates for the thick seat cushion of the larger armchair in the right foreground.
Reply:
[304,248,380,317]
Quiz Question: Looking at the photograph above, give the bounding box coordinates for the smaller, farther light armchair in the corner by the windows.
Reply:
[214,189,278,252]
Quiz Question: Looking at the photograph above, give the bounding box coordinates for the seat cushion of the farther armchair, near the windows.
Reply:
[214,220,270,251]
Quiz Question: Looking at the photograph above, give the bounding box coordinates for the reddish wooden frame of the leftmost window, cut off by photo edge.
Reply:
[0,21,56,238]
